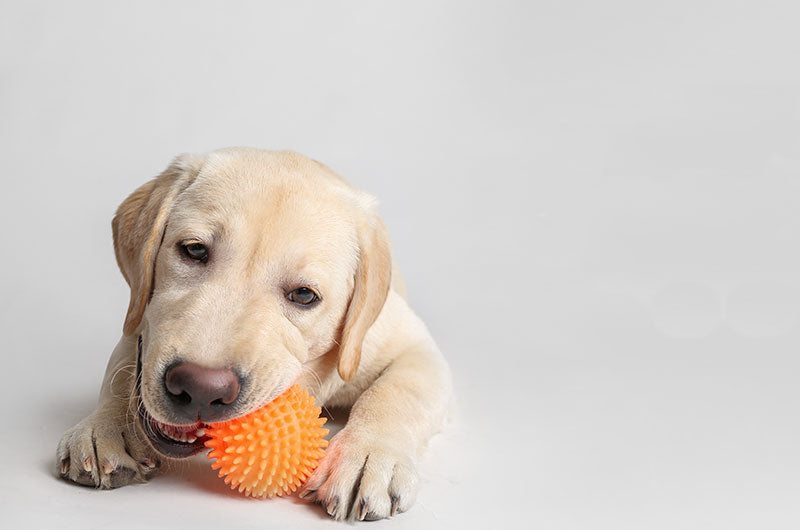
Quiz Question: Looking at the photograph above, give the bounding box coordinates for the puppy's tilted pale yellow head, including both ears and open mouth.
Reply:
[112,148,391,457]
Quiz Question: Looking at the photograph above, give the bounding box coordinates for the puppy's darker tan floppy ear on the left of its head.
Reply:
[111,155,197,335]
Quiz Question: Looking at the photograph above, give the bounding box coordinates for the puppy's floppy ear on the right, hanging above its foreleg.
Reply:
[338,202,392,381]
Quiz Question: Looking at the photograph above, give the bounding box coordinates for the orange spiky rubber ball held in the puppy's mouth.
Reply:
[206,385,328,498]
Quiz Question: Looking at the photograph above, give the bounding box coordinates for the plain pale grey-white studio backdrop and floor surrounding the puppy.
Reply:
[0,0,800,530]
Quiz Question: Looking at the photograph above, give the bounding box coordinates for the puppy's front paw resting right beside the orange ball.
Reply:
[300,428,418,521]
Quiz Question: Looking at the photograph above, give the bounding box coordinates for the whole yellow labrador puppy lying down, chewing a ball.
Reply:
[58,148,451,519]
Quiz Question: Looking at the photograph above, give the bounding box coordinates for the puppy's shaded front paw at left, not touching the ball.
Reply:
[56,411,161,489]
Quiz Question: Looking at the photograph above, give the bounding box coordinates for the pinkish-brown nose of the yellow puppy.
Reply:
[164,362,241,422]
